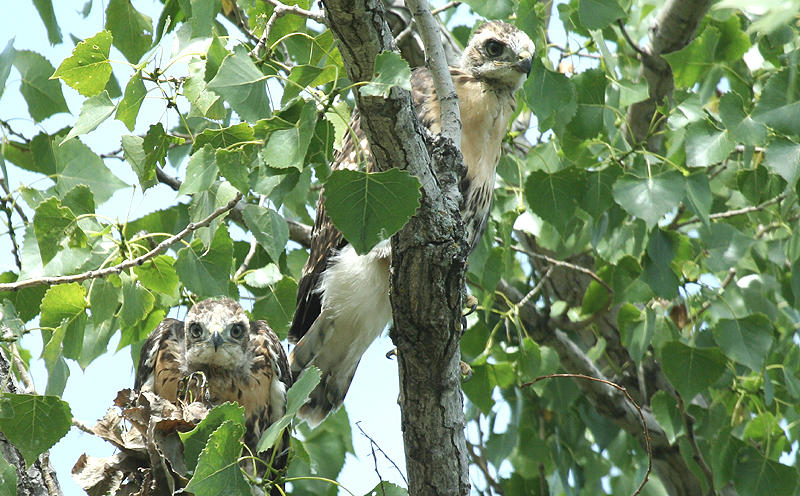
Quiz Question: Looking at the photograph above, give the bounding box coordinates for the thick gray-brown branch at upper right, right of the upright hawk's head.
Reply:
[626,0,711,150]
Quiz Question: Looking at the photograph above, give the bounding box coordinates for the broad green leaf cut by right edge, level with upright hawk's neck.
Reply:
[752,68,800,136]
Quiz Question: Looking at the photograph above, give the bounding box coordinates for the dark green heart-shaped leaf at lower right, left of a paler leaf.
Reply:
[661,341,725,402]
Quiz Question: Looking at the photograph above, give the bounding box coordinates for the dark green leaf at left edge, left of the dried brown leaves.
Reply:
[0,393,72,467]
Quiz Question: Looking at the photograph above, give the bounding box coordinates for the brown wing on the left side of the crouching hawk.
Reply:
[133,319,184,401]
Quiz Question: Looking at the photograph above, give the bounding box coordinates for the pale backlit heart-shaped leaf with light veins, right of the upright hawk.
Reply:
[613,170,686,227]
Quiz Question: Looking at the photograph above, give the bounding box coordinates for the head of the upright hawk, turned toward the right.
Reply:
[461,21,534,92]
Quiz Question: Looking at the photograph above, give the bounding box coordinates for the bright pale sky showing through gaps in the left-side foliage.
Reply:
[0,0,405,496]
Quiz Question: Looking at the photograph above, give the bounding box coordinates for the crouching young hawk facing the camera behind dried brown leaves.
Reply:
[134,298,292,494]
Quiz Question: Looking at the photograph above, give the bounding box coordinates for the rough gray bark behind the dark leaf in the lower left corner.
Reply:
[0,348,63,496]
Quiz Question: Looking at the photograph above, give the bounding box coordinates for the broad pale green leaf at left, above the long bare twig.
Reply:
[53,140,127,205]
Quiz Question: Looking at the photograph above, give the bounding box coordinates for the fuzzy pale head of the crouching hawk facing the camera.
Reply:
[184,298,250,372]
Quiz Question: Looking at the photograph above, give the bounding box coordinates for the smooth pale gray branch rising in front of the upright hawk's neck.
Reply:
[406,0,461,149]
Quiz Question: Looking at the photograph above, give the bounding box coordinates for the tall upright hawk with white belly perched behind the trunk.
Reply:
[289,21,534,425]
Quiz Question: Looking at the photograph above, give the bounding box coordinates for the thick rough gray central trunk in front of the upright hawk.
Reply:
[323,0,469,496]
